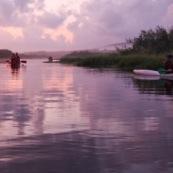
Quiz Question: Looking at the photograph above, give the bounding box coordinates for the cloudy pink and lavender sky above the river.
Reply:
[0,0,173,52]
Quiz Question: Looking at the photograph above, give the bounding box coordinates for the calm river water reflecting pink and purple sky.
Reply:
[0,60,173,173]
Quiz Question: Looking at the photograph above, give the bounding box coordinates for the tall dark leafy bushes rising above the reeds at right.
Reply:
[119,26,173,54]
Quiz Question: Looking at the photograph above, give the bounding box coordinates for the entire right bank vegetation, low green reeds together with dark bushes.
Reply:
[59,27,173,70]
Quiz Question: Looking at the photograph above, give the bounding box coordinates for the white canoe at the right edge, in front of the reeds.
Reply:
[133,69,173,79]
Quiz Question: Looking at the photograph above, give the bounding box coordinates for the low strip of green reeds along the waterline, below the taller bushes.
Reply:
[59,52,165,71]
